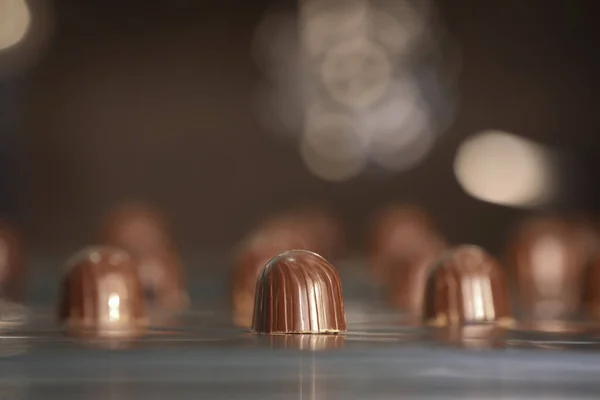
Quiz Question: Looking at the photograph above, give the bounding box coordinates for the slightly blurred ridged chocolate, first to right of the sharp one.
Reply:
[423,245,513,326]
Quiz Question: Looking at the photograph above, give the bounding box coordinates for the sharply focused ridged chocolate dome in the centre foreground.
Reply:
[252,250,346,333]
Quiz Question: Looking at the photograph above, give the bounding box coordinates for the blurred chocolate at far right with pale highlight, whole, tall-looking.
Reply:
[508,218,597,320]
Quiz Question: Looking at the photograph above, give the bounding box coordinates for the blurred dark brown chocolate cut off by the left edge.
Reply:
[0,223,26,301]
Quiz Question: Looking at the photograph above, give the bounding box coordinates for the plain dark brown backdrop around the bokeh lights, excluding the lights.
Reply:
[0,0,600,260]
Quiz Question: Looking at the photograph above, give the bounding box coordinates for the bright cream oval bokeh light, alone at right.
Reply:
[454,131,556,207]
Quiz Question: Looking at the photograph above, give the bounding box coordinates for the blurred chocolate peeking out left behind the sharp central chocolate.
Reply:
[230,227,308,328]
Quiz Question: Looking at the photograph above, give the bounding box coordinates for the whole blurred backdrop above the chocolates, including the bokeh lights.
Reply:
[0,0,600,255]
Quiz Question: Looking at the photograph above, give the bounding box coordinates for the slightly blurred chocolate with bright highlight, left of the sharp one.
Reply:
[59,247,147,338]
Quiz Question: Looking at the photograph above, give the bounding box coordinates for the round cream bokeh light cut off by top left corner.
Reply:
[0,0,31,51]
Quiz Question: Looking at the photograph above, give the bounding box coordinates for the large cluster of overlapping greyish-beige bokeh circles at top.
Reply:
[253,0,456,180]
